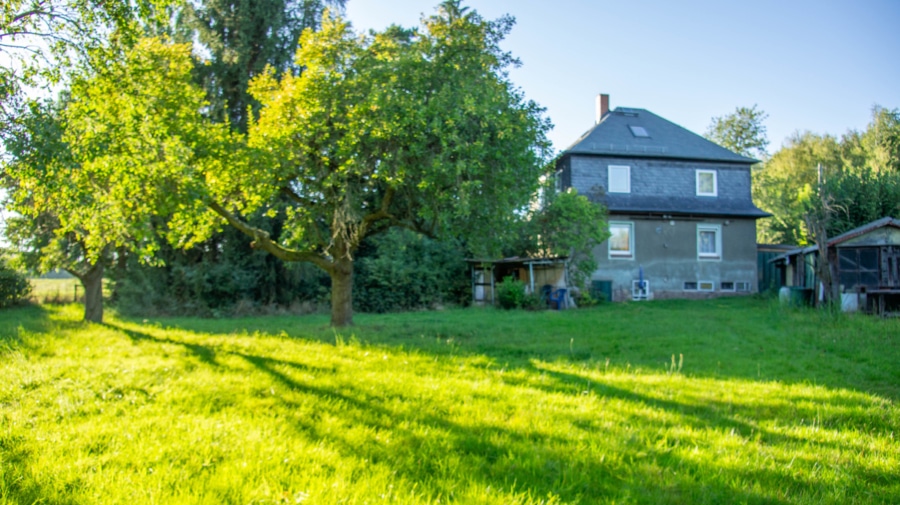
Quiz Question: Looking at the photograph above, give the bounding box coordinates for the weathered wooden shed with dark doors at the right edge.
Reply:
[772,217,900,314]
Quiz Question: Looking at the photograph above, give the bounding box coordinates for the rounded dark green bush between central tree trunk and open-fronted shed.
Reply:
[353,229,472,312]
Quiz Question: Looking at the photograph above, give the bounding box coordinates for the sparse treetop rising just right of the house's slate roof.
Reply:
[706,104,769,159]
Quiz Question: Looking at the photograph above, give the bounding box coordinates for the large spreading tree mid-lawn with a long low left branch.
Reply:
[54,1,550,326]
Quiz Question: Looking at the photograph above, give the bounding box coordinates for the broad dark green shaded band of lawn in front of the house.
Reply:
[128,301,900,402]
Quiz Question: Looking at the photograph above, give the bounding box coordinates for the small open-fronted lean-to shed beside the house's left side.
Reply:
[466,256,571,306]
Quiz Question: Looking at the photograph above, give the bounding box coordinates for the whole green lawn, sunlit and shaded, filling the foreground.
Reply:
[0,298,900,504]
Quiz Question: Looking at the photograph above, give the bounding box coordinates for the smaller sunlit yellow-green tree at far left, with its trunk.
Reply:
[3,39,229,322]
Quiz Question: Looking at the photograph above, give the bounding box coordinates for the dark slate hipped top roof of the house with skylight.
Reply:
[563,107,758,165]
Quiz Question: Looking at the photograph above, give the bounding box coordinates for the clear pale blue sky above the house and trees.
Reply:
[346,0,900,153]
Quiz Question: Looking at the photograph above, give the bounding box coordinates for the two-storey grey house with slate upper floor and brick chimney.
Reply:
[556,95,769,300]
